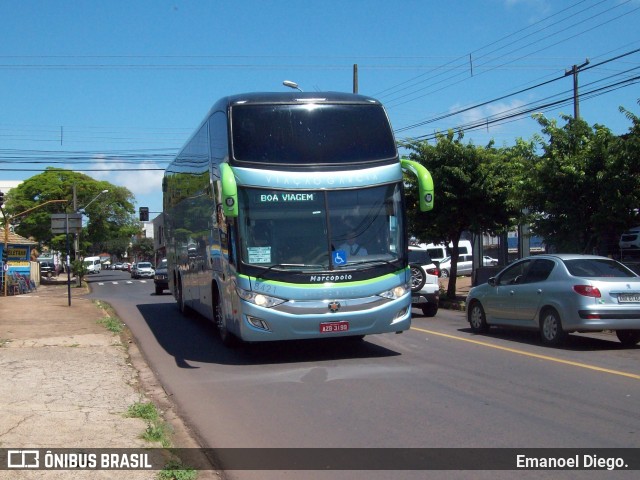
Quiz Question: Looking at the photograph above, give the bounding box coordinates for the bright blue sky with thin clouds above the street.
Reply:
[0,0,640,217]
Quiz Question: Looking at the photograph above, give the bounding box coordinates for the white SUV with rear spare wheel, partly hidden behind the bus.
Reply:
[409,246,440,317]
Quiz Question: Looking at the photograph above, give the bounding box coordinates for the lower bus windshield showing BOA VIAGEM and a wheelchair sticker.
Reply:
[238,183,405,271]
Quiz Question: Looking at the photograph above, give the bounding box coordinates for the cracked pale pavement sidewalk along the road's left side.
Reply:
[0,284,219,480]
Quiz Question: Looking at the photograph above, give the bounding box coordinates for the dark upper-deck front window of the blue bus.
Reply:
[231,104,397,166]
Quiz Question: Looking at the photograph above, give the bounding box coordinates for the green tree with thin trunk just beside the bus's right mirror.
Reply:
[403,131,533,298]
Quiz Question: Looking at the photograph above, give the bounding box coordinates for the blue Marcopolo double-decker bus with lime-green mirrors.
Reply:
[163,92,433,345]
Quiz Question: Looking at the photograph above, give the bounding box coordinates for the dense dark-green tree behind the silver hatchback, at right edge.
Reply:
[523,112,640,254]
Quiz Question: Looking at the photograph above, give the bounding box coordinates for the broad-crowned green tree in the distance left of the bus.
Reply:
[6,168,139,255]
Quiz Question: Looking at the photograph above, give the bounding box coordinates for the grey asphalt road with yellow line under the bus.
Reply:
[89,271,640,479]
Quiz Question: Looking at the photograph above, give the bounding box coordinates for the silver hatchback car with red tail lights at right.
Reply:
[467,254,640,346]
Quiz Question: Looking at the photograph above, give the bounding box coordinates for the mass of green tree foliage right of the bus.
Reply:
[404,100,640,282]
